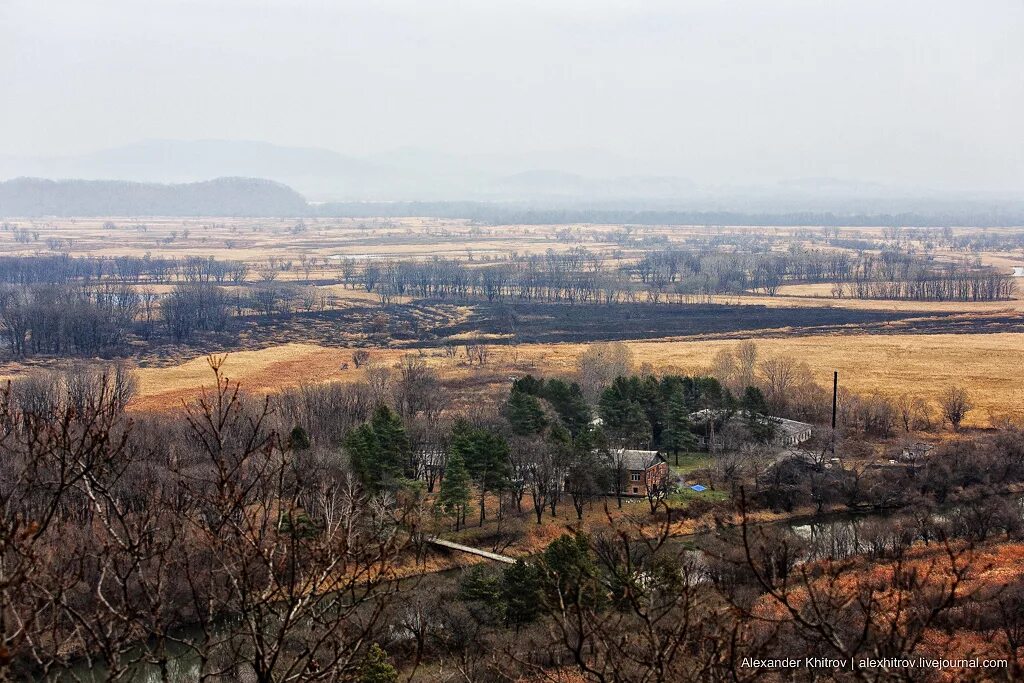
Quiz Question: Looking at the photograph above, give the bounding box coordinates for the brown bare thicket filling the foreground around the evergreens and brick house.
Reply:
[0,356,1024,681]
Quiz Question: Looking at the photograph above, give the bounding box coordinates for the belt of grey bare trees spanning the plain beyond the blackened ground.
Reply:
[0,241,1014,362]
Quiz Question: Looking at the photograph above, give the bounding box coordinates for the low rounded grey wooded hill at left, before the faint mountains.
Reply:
[0,178,308,217]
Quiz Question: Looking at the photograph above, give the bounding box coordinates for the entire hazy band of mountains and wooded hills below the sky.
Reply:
[0,140,1024,220]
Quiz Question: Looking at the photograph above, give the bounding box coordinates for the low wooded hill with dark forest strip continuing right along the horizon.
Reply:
[0,177,1024,227]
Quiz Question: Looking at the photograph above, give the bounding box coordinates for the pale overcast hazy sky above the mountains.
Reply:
[0,0,1024,190]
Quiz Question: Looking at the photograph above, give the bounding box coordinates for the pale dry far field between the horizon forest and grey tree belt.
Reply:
[9,216,1024,272]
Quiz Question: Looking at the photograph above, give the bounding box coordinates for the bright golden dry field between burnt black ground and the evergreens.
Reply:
[128,334,1024,426]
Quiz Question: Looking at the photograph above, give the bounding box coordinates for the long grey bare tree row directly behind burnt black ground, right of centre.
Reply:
[360,245,1015,303]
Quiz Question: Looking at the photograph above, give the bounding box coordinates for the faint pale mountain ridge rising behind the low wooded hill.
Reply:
[0,140,695,201]
